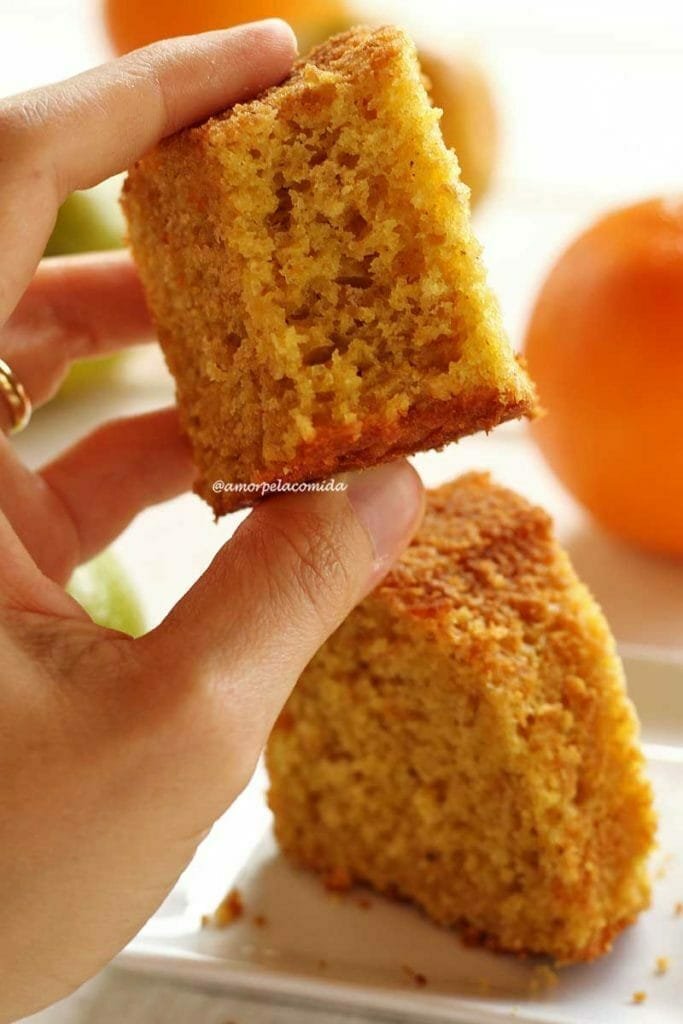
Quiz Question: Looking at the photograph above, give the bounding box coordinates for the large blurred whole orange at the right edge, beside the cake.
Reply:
[525,199,683,555]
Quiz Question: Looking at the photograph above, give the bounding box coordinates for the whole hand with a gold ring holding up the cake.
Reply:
[0,22,422,1021]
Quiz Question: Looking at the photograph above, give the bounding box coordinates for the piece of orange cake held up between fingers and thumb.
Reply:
[123,28,535,514]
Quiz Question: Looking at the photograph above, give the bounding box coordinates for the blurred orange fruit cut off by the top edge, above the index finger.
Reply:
[103,0,346,53]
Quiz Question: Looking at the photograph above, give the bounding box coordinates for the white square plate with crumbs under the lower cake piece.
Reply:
[117,650,683,1024]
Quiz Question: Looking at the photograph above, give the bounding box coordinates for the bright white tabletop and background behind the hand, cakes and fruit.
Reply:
[0,0,683,1024]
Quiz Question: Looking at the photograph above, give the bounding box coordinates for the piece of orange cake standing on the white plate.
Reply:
[267,474,655,964]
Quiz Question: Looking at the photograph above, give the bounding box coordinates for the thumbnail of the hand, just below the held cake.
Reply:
[346,459,424,586]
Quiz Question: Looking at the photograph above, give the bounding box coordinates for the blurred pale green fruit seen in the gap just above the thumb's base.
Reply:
[67,550,146,637]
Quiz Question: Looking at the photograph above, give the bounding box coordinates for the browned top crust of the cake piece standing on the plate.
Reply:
[375,473,589,651]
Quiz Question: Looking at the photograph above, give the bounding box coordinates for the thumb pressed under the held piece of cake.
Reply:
[136,460,424,760]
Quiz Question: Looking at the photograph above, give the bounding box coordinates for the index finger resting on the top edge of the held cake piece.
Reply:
[0,19,296,323]
